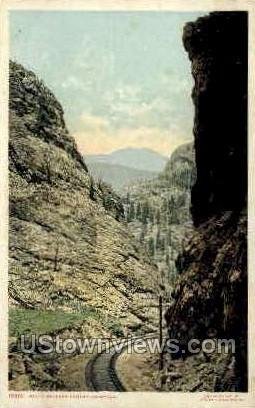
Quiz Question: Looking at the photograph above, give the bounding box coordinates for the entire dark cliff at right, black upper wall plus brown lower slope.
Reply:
[166,12,247,391]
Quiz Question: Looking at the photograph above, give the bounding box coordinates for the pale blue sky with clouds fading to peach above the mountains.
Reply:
[10,11,205,155]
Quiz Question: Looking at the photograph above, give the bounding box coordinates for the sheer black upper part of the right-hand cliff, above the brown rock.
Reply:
[183,12,248,223]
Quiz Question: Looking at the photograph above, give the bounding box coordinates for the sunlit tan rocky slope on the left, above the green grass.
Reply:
[9,62,157,327]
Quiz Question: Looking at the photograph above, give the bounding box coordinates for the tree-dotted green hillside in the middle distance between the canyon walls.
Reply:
[124,144,195,286]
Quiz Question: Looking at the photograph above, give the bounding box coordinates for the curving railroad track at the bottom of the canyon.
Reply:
[85,334,155,391]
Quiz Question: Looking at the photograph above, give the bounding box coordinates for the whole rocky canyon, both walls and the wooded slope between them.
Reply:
[9,12,248,391]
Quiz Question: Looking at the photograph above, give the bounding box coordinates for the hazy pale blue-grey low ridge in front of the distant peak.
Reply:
[86,156,157,194]
